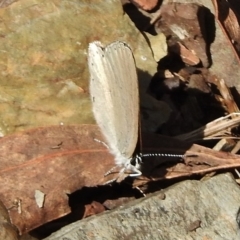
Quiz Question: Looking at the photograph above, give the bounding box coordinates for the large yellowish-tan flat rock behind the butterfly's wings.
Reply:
[0,0,161,136]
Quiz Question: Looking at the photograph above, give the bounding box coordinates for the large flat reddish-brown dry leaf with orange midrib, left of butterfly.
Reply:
[0,125,114,234]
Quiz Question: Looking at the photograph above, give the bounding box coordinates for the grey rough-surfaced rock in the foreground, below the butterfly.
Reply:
[42,173,240,240]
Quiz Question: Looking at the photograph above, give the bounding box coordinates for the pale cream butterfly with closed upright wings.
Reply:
[88,41,141,176]
